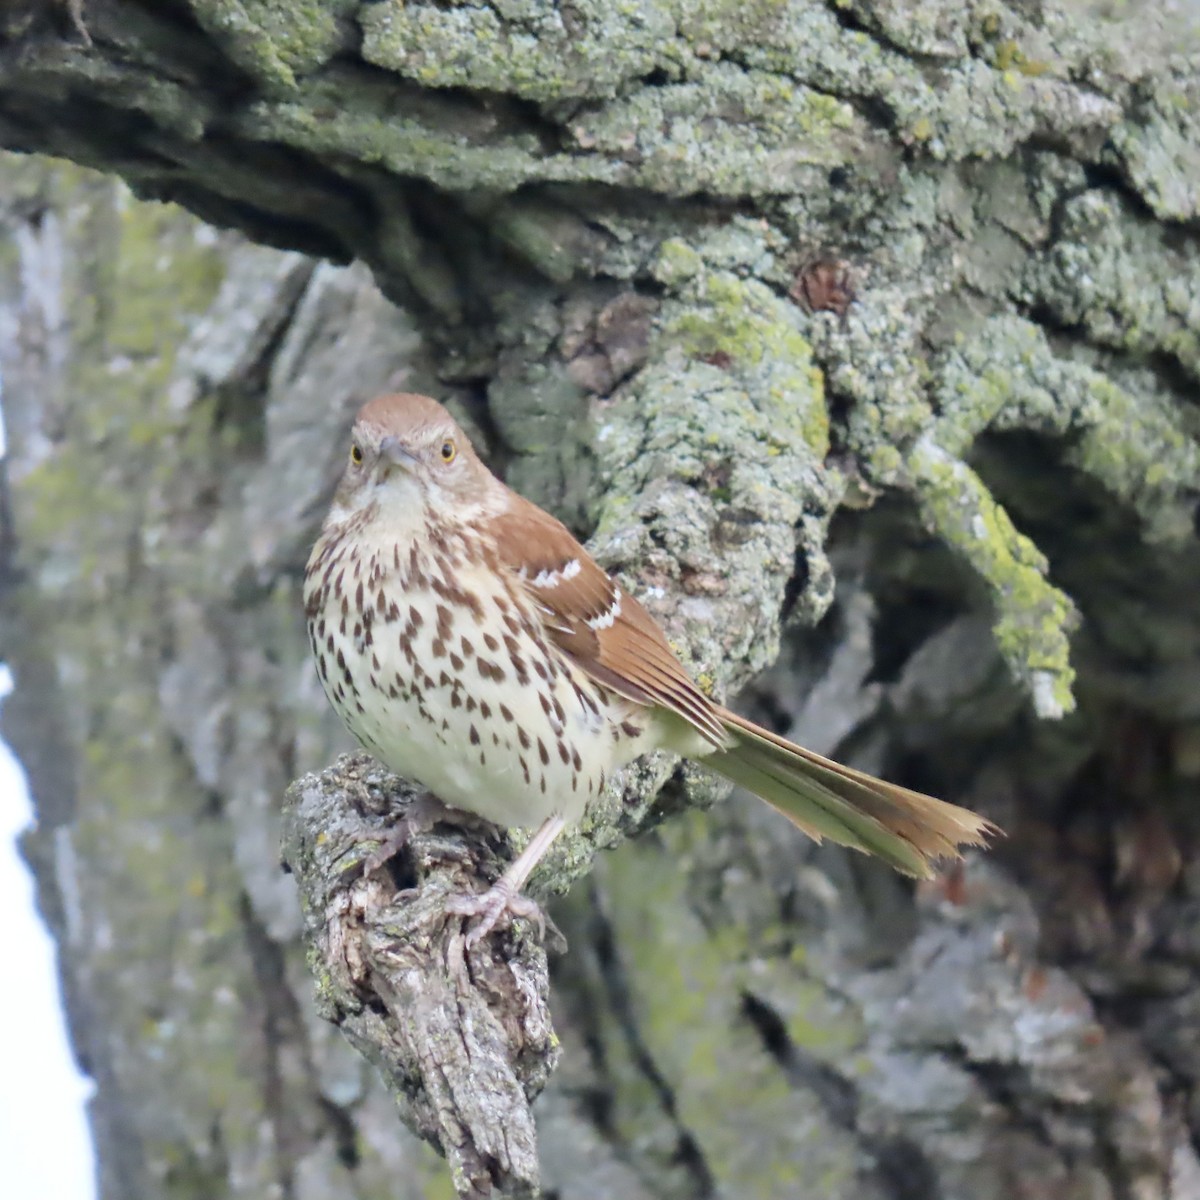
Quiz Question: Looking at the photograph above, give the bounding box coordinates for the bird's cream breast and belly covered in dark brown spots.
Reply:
[305,504,643,827]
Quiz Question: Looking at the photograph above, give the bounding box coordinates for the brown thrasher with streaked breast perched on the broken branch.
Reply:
[305,395,994,941]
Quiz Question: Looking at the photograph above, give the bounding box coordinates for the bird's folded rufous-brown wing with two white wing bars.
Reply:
[492,492,730,748]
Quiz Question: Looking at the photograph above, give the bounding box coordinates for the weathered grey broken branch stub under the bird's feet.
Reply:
[283,755,558,1198]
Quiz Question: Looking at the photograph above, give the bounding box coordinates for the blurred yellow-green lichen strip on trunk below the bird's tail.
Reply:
[601,812,857,1200]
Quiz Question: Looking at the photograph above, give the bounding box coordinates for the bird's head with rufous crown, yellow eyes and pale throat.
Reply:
[332,392,504,523]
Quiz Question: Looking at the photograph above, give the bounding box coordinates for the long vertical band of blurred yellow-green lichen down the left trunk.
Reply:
[6,166,319,1194]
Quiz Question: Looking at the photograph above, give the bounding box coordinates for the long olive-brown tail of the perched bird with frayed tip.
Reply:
[703,708,1000,878]
